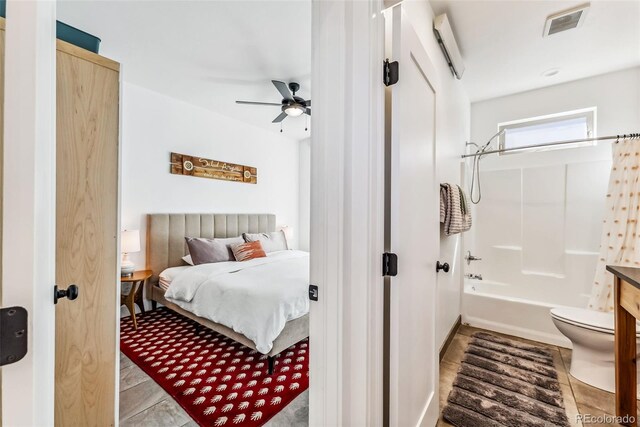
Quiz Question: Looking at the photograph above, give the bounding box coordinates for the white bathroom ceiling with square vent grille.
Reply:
[431,0,640,102]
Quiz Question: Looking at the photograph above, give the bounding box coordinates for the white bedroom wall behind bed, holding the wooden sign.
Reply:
[122,83,299,273]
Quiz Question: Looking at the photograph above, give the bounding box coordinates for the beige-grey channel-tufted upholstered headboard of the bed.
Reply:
[147,214,276,284]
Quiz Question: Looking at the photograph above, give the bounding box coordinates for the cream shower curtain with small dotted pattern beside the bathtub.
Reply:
[589,138,640,311]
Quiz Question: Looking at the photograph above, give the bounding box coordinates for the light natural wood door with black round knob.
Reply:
[55,41,119,426]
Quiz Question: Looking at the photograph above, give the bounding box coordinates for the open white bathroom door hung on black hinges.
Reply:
[386,5,440,426]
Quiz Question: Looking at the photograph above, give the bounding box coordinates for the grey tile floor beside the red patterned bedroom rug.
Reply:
[120,353,309,427]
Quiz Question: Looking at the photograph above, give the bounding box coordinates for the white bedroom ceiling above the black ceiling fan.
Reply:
[57,0,311,139]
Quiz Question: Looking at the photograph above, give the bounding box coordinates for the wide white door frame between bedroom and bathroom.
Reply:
[309,0,384,426]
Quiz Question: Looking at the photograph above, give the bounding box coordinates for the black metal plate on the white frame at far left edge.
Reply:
[0,307,29,366]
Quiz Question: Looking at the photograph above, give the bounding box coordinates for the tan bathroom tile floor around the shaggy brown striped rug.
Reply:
[438,325,640,427]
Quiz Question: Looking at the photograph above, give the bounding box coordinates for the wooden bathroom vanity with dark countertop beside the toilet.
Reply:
[607,265,640,426]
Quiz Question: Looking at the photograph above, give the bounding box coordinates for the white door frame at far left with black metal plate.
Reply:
[2,0,56,426]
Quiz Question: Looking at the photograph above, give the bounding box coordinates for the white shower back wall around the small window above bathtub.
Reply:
[465,68,640,306]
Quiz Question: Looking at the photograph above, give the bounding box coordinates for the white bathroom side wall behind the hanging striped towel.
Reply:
[400,0,470,352]
